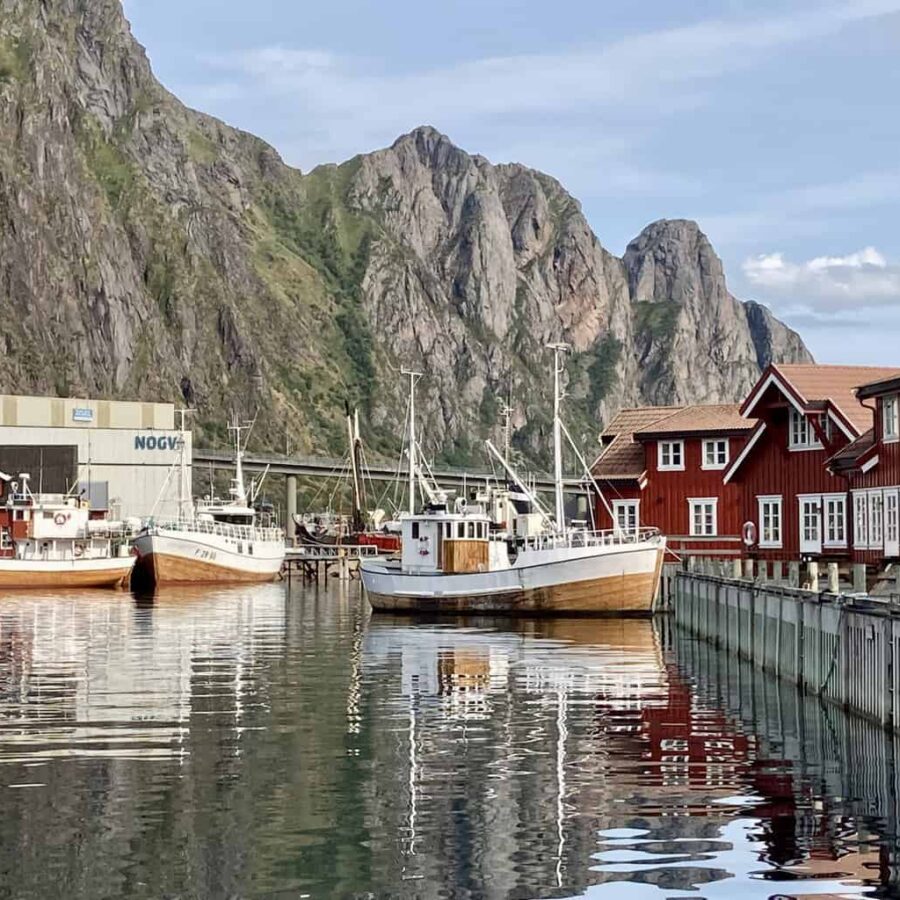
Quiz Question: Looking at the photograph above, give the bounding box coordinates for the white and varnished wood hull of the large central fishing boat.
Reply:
[360,543,665,616]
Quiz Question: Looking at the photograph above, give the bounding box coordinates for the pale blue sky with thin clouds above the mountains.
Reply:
[125,0,900,365]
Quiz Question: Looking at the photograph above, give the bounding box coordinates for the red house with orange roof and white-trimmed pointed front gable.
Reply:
[723,364,900,560]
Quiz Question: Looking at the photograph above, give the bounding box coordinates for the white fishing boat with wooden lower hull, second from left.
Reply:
[134,419,285,585]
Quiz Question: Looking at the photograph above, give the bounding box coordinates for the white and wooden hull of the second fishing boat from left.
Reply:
[134,533,284,585]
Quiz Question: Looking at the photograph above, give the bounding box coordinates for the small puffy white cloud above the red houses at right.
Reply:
[741,247,900,315]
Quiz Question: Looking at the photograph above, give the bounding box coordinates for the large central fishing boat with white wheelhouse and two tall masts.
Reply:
[360,344,666,615]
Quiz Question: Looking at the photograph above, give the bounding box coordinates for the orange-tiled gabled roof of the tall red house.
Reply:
[741,363,900,437]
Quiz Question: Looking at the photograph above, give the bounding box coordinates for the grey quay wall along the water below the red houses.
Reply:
[669,571,900,731]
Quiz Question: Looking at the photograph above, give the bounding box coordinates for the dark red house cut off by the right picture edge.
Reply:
[829,372,900,565]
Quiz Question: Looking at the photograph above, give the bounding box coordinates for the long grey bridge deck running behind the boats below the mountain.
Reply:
[193,448,587,495]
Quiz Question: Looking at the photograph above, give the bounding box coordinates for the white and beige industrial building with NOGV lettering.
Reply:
[0,394,191,518]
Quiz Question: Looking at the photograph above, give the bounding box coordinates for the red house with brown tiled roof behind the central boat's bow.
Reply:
[592,404,754,556]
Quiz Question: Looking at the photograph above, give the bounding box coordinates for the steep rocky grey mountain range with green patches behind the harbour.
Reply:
[0,0,810,461]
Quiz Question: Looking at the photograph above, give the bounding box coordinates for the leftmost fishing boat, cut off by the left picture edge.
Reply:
[0,472,134,588]
